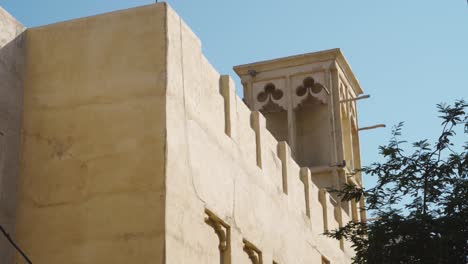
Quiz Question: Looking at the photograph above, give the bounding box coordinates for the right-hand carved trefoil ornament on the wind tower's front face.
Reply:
[296,77,327,107]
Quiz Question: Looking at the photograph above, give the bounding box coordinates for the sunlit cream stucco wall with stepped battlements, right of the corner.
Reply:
[166,4,353,264]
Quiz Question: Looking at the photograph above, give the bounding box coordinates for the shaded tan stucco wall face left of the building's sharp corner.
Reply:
[17,4,166,264]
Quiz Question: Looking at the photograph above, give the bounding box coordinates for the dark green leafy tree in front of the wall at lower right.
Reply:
[326,100,468,264]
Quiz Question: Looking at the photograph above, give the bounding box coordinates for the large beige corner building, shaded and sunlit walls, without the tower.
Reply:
[4,4,362,264]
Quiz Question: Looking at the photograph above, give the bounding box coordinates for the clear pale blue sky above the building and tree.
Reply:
[0,0,468,189]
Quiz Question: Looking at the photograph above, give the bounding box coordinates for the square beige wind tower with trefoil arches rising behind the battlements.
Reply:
[234,49,363,219]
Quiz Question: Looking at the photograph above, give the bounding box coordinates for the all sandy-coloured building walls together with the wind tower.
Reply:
[0,3,365,264]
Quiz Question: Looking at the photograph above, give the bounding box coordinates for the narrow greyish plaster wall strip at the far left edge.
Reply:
[0,7,25,263]
